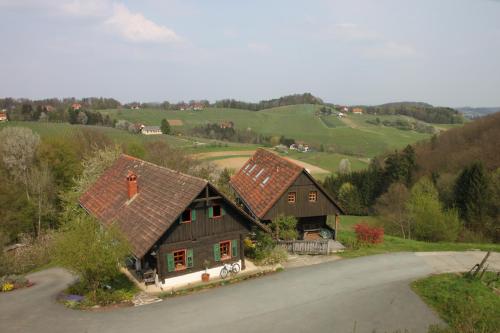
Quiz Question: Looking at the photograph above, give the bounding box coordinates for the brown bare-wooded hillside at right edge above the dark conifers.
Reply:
[416,113,500,175]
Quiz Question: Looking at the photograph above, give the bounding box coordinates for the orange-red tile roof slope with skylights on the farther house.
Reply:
[231,149,304,218]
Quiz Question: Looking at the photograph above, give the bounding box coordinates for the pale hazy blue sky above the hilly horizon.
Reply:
[0,0,500,107]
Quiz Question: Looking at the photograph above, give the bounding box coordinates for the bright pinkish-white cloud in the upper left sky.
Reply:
[104,3,181,43]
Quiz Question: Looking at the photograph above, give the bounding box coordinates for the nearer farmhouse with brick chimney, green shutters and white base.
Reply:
[80,155,267,288]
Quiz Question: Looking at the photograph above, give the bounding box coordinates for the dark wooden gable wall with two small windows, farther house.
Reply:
[263,173,340,220]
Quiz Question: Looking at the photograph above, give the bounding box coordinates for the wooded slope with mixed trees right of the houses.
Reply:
[324,113,500,242]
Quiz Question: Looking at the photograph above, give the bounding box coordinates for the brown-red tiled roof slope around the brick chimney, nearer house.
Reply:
[80,155,208,258]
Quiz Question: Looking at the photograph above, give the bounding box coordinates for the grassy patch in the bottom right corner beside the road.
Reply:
[412,272,500,333]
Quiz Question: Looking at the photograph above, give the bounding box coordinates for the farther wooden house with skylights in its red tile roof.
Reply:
[231,149,343,237]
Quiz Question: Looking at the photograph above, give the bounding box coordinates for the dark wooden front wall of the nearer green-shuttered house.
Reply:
[156,185,252,279]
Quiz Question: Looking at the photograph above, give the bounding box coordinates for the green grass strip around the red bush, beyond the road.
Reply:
[329,216,500,258]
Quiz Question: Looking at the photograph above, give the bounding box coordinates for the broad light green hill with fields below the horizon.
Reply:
[102,105,442,157]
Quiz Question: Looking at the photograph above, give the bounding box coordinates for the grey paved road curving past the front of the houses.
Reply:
[0,253,500,333]
